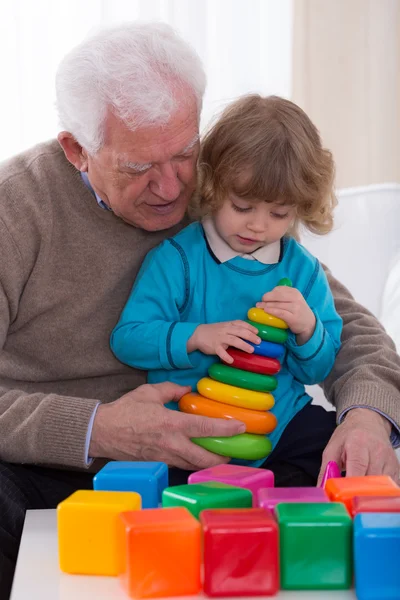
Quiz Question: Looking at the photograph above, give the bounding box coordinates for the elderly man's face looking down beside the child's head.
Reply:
[83,99,199,231]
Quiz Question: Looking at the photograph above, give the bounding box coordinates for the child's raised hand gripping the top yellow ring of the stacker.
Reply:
[256,286,315,346]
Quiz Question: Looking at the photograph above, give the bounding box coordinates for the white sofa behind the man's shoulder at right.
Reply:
[302,184,400,456]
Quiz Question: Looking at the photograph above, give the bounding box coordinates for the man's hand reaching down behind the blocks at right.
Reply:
[318,408,400,485]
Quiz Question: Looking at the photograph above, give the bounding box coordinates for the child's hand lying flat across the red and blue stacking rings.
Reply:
[187,321,261,363]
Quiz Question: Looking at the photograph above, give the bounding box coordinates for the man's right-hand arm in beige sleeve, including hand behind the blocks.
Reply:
[318,267,400,484]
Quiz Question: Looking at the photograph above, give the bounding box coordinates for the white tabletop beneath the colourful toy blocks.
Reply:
[11,510,356,600]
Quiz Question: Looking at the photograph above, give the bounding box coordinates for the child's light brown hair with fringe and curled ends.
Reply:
[191,94,337,237]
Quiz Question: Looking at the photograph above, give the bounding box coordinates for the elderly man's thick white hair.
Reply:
[56,23,206,154]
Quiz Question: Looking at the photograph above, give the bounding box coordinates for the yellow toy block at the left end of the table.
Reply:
[57,490,142,576]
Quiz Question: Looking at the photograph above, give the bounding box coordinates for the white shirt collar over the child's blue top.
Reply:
[202,217,281,265]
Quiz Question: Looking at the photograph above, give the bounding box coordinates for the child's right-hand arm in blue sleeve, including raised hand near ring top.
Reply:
[262,263,342,385]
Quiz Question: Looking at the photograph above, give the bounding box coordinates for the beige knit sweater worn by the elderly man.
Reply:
[0,140,400,468]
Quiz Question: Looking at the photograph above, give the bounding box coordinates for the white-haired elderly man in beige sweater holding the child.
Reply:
[0,25,400,597]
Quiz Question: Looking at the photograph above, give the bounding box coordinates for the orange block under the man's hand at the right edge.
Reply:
[325,475,400,514]
